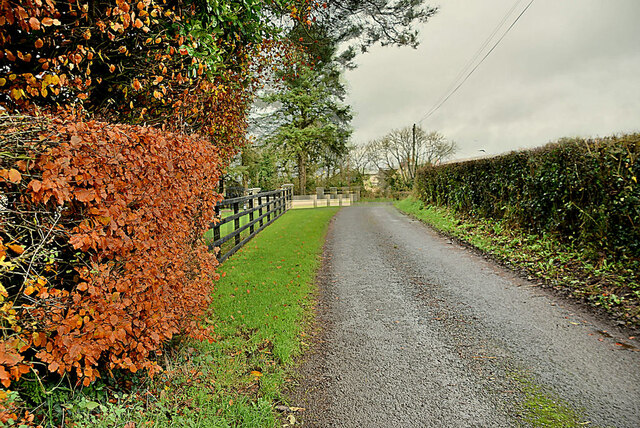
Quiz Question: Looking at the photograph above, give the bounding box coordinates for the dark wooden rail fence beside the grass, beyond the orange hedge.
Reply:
[209,184,293,263]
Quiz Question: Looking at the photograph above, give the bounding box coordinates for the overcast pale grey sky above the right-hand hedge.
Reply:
[346,0,640,158]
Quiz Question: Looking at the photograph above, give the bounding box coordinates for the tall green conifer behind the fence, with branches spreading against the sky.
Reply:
[242,0,436,193]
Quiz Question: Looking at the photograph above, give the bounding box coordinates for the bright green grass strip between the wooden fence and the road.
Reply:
[66,208,338,427]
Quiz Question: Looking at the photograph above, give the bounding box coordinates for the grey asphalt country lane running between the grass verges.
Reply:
[292,204,640,427]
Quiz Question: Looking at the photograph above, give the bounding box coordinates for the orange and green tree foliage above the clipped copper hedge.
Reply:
[0,0,316,147]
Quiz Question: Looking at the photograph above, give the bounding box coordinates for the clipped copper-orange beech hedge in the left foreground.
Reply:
[0,116,221,387]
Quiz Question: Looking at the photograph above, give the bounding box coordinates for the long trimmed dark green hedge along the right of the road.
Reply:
[414,134,640,258]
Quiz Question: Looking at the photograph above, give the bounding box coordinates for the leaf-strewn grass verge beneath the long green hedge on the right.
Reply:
[395,197,640,328]
